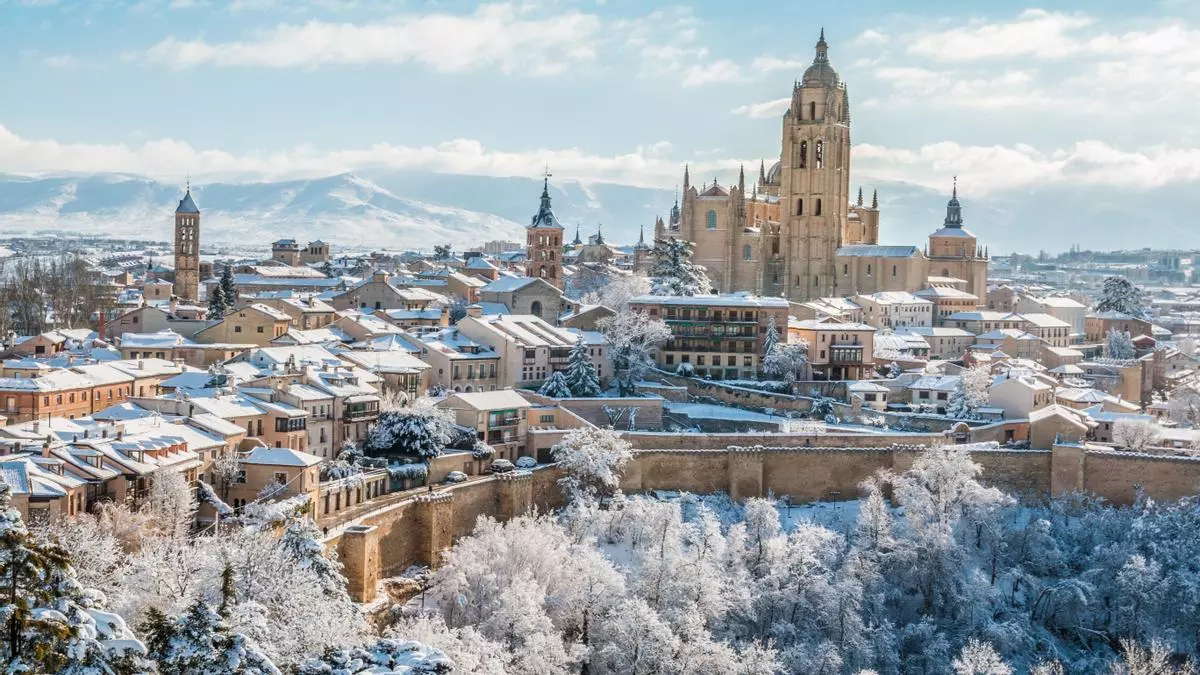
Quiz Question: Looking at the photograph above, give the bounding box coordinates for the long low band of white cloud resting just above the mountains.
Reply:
[7,121,1200,195]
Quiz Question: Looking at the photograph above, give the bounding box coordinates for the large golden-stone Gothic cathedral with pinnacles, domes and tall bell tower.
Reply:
[655,31,988,301]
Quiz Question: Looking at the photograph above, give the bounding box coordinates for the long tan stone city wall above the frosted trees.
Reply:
[326,441,1200,602]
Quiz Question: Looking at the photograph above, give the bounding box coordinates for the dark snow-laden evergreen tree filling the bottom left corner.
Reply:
[0,483,145,675]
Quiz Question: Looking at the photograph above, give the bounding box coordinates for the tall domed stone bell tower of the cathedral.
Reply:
[779,30,850,301]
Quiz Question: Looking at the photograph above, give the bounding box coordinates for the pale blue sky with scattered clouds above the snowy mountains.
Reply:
[0,0,1200,195]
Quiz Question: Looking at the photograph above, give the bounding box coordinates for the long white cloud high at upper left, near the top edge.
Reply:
[146,4,601,74]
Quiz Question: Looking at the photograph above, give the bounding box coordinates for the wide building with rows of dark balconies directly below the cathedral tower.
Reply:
[630,293,788,380]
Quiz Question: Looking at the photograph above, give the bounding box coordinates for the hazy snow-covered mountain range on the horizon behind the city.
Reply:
[0,171,1200,253]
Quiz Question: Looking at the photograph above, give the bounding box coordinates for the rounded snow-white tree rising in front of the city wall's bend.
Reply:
[551,426,634,498]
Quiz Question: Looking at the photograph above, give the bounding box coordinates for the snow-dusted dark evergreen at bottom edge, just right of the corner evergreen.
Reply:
[142,601,280,675]
